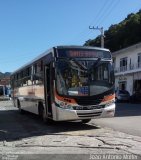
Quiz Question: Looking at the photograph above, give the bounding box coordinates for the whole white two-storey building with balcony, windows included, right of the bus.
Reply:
[112,43,141,95]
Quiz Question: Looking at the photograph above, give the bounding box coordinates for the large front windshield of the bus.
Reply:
[56,58,114,96]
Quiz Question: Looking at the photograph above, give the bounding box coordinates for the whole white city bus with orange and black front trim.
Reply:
[11,46,115,123]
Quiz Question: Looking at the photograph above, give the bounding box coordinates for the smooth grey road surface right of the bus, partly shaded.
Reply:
[90,103,141,137]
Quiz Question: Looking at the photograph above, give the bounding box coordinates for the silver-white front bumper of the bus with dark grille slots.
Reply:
[53,103,115,121]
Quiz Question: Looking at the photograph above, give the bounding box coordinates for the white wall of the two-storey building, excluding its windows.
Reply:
[113,43,141,95]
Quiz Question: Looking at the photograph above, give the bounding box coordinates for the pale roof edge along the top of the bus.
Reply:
[11,45,109,75]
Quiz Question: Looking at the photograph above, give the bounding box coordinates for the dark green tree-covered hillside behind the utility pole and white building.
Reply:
[84,10,141,52]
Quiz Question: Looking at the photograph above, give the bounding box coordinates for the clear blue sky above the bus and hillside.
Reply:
[0,0,141,72]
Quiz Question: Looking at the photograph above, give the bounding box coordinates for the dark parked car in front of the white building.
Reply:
[115,90,130,102]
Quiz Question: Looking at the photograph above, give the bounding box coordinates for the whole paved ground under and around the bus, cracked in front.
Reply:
[0,101,141,160]
